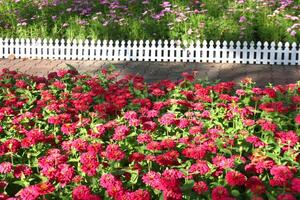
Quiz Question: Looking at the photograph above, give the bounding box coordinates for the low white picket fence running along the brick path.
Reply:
[0,38,300,65]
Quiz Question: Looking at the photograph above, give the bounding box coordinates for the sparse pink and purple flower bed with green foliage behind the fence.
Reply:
[0,0,300,42]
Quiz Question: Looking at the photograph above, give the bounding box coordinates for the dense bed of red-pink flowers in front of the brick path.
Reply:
[0,66,300,200]
